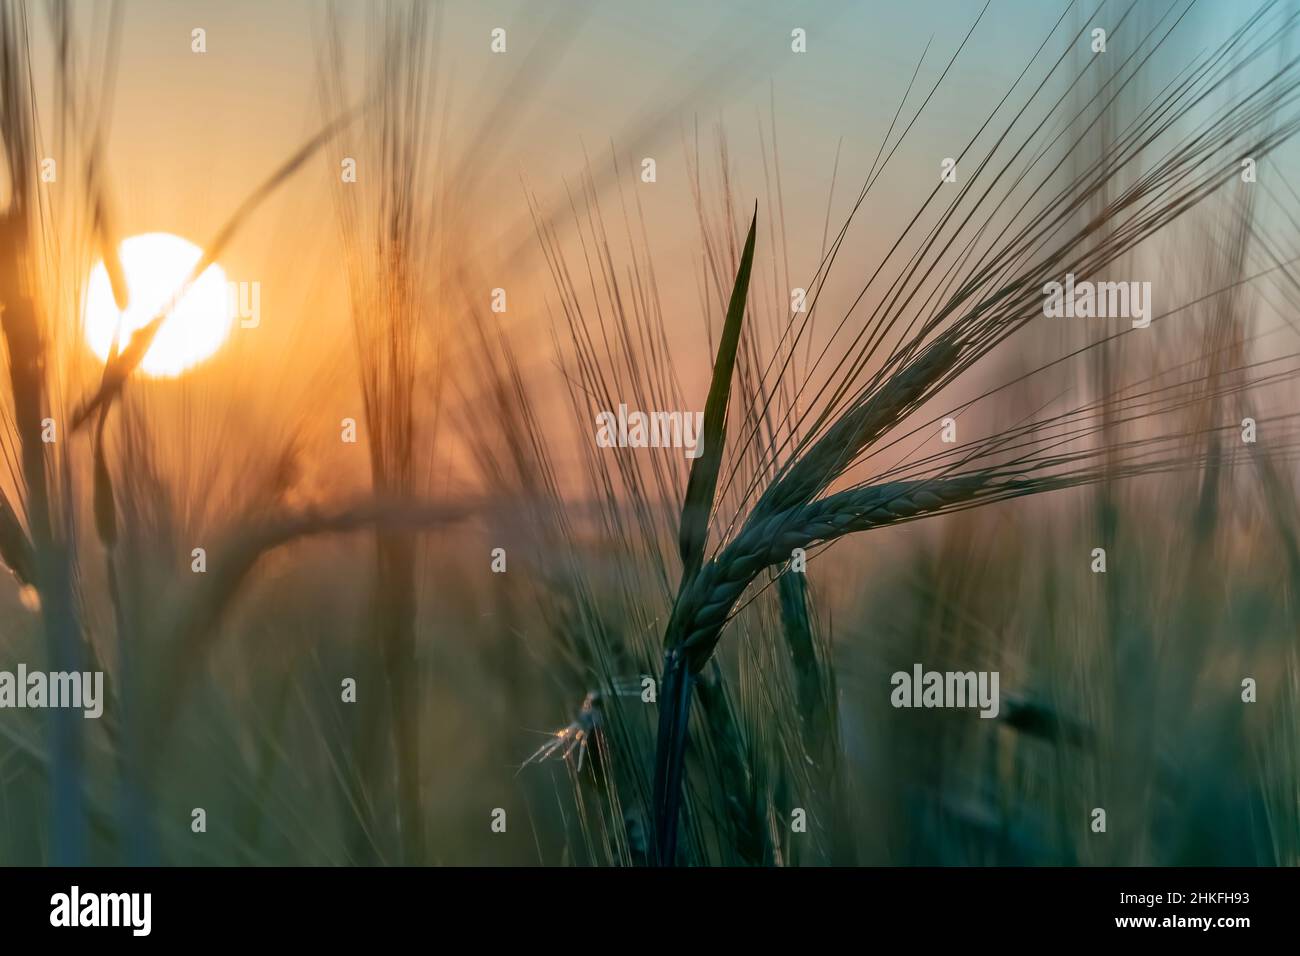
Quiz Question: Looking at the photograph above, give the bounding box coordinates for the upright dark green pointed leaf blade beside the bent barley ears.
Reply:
[679,203,758,585]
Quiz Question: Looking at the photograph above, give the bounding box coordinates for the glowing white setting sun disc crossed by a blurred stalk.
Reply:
[83,233,233,377]
